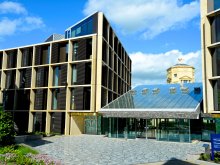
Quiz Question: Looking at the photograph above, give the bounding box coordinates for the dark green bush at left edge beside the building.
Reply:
[0,108,15,146]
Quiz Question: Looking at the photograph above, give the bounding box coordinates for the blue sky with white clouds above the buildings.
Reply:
[0,0,202,87]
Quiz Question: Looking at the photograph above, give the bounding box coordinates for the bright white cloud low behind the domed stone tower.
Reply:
[130,50,202,86]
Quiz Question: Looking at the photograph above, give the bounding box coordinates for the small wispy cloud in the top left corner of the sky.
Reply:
[0,1,27,14]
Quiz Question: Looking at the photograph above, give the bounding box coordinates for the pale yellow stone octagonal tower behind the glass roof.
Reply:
[167,59,195,84]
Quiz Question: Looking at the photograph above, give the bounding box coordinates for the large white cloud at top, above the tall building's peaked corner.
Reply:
[83,0,200,39]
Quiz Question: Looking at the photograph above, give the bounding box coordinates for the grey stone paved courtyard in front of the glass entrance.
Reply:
[25,135,208,165]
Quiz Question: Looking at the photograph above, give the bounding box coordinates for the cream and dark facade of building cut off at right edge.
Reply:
[201,0,220,114]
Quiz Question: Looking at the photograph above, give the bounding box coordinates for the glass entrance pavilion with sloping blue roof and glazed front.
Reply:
[100,83,202,142]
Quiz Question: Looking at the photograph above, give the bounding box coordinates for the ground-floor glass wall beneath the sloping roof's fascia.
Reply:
[101,118,218,142]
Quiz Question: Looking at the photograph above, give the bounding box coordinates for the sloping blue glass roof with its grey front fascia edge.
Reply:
[99,83,202,119]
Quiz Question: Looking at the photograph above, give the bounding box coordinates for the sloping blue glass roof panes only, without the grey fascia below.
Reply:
[102,83,202,111]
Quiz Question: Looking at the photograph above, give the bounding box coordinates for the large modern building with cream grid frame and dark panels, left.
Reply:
[0,12,131,135]
